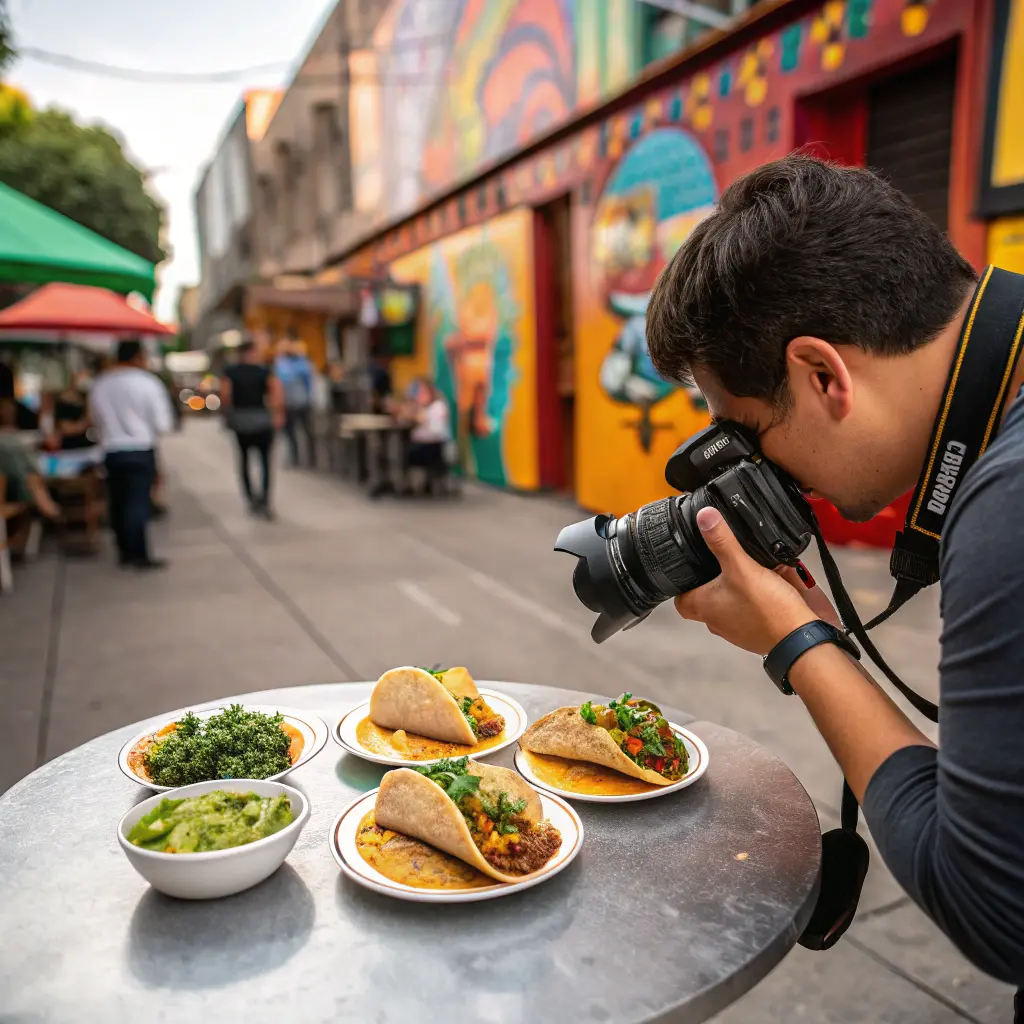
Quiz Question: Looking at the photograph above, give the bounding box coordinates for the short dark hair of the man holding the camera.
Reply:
[647,154,977,406]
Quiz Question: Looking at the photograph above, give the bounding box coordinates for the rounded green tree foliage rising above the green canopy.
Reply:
[0,107,166,263]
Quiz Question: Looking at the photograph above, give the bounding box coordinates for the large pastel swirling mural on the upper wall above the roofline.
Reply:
[349,0,639,224]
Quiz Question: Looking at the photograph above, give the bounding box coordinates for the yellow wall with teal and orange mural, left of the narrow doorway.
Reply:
[390,209,540,490]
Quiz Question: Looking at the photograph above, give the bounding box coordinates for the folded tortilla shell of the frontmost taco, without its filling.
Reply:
[374,761,544,882]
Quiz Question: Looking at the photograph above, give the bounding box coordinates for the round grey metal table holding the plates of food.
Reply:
[0,683,820,1024]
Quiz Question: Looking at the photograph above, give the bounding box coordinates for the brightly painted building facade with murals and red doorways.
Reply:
[338,0,999,514]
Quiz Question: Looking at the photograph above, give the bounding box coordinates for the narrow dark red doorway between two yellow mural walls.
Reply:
[535,195,575,494]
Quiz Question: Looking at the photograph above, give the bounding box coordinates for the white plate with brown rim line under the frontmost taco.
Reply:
[328,790,583,903]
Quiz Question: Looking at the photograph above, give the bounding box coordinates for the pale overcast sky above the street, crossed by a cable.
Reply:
[7,0,334,317]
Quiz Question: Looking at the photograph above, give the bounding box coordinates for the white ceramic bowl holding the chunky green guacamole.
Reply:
[118,778,309,899]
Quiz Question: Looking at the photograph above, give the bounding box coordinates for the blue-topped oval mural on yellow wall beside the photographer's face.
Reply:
[591,128,718,452]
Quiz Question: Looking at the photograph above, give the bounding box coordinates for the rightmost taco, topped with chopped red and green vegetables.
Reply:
[519,693,688,785]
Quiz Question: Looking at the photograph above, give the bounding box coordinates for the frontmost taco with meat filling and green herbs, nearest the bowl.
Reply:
[374,758,562,882]
